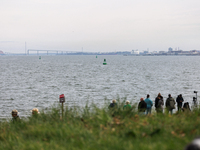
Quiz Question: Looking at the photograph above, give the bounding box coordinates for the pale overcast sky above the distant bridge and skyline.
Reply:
[0,0,200,53]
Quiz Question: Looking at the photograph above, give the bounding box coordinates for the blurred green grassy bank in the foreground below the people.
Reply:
[0,98,200,150]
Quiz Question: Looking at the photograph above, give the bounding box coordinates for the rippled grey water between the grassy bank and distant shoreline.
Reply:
[0,56,200,118]
